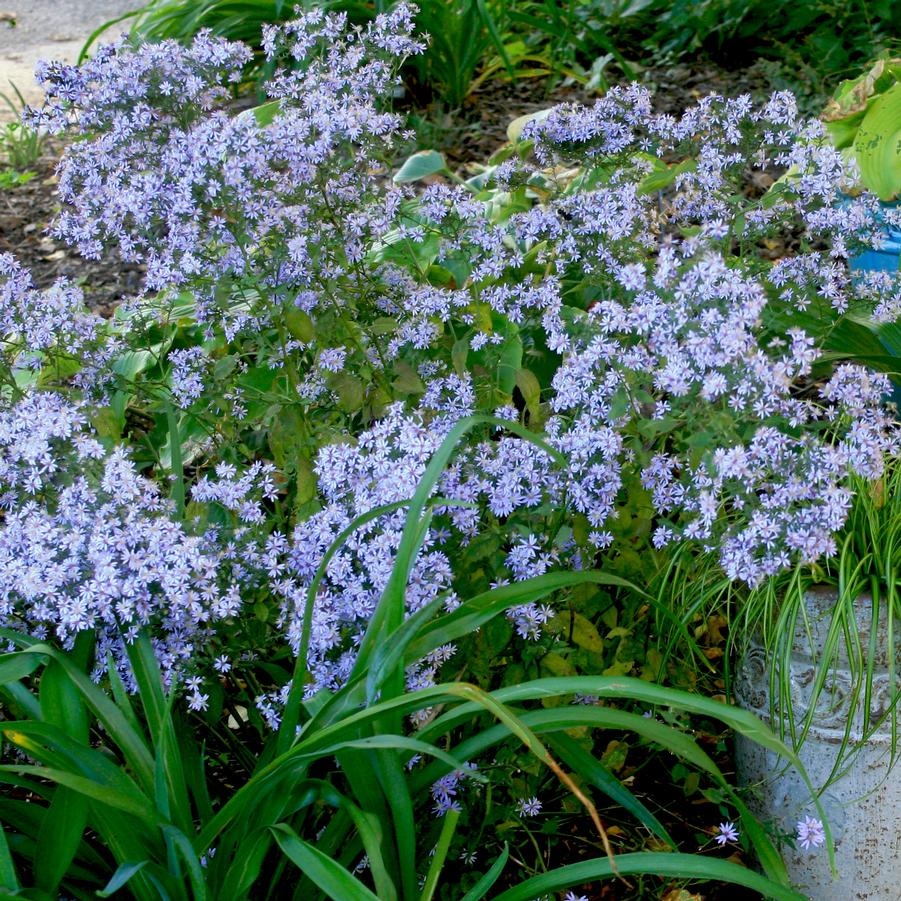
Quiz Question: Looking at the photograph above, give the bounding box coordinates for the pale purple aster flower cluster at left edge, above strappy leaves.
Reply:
[0,392,240,677]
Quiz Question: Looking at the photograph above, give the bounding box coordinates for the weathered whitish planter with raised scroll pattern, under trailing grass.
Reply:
[736,590,901,901]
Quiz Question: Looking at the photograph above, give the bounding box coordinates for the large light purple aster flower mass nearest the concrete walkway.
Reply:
[32,5,423,350]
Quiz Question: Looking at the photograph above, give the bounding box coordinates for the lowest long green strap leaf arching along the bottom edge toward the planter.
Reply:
[493,852,806,901]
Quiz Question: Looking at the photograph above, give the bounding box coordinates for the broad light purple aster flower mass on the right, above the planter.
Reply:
[368,86,901,585]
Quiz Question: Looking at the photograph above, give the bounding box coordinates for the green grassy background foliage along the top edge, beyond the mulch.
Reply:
[85,0,901,109]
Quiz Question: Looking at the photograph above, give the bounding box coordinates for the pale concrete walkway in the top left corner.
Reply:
[0,0,136,121]
